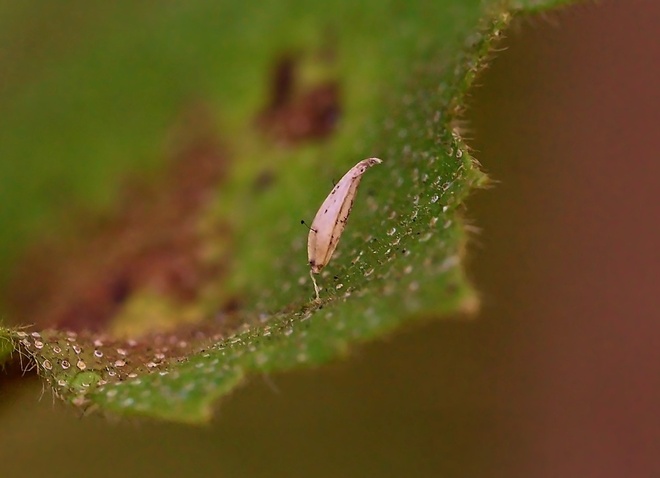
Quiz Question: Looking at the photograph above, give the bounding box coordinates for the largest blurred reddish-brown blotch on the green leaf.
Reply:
[6,102,235,331]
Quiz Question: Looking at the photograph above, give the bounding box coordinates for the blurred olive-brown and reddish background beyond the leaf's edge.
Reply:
[0,1,660,477]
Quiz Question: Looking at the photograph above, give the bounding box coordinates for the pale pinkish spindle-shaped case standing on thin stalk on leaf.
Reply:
[307,158,382,300]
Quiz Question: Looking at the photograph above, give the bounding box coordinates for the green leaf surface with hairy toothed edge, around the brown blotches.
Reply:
[0,0,560,422]
